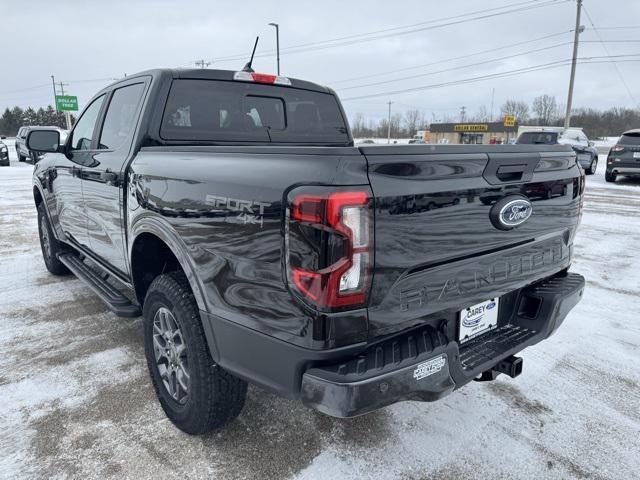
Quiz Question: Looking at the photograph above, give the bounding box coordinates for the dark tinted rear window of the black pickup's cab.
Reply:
[160,79,350,145]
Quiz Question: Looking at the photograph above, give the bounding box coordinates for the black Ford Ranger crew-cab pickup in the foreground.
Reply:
[27,70,585,433]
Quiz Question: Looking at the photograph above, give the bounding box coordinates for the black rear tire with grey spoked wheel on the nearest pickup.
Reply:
[143,272,247,435]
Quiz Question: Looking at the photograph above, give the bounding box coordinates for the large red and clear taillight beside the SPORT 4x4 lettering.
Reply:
[287,191,373,308]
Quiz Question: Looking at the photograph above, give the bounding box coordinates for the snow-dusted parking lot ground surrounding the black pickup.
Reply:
[0,152,640,480]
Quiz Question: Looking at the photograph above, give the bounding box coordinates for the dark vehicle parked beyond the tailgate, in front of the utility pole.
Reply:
[516,127,598,175]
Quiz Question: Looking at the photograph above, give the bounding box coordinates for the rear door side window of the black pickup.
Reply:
[98,83,144,150]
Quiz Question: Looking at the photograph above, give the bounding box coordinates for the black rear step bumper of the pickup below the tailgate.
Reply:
[301,274,585,417]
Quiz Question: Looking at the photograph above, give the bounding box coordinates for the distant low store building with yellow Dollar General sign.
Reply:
[430,122,518,145]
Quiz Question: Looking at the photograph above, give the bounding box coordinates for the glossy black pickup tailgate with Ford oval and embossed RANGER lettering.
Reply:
[360,145,583,335]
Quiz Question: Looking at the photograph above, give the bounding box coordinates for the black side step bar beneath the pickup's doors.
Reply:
[58,252,140,317]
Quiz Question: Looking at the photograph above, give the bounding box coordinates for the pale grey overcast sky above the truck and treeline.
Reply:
[0,0,640,120]
